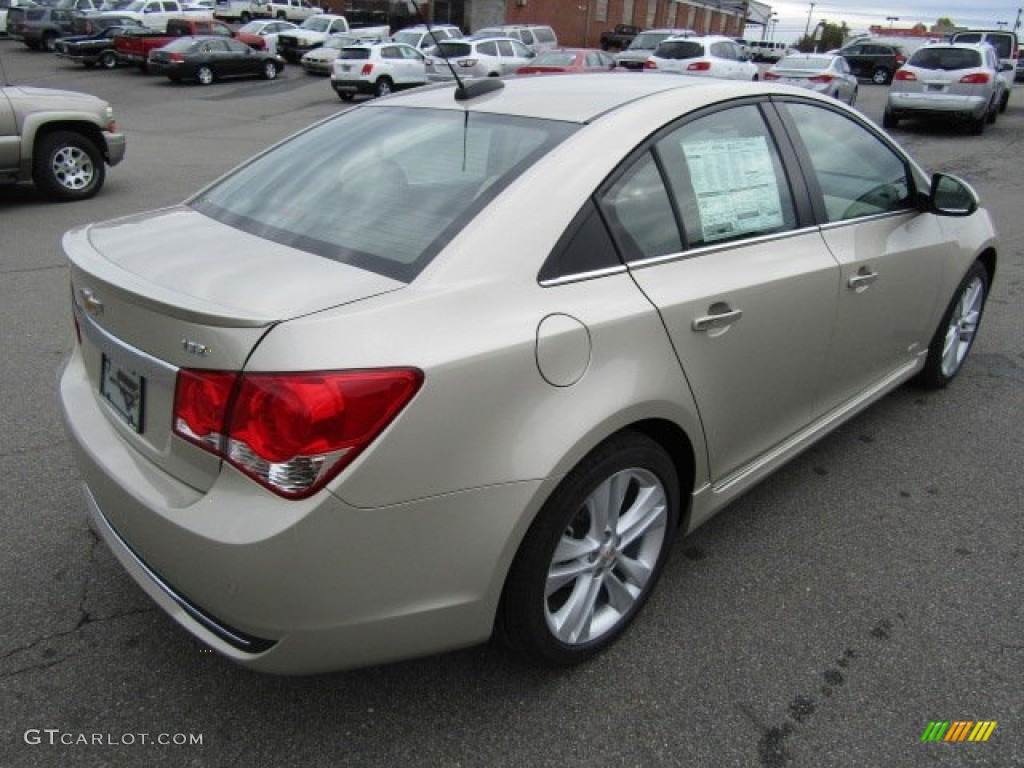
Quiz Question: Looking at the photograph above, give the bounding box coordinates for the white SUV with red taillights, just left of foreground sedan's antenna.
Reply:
[331,42,427,101]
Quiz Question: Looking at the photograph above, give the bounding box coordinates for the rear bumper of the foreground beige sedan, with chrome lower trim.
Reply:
[59,349,540,674]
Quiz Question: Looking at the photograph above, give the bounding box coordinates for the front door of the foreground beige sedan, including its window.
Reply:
[780,101,957,410]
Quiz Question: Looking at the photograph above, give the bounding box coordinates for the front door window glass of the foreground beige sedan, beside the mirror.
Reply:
[785,103,912,221]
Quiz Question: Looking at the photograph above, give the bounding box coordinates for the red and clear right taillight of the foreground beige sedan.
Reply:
[174,369,423,499]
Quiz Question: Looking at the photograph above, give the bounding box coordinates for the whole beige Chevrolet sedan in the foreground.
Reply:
[59,74,998,673]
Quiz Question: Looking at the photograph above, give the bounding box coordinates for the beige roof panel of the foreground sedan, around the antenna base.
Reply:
[356,73,778,123]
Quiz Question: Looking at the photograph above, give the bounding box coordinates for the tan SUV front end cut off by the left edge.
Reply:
[0,86,125,200]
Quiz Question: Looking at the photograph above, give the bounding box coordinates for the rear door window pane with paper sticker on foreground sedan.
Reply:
[657,105,797,248]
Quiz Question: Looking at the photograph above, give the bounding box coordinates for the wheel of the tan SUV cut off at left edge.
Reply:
[32,131,104,200]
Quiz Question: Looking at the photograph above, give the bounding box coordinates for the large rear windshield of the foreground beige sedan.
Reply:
[189,106,578,282]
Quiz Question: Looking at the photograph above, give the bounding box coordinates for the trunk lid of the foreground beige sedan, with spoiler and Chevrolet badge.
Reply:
[65,207,404,490]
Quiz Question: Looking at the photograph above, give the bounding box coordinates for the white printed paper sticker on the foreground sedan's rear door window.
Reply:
[682,136,783,243]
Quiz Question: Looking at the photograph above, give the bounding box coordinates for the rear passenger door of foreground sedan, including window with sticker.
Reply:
[600,102,839,482]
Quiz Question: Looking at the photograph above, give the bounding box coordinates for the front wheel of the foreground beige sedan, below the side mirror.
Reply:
[916,261,988,389]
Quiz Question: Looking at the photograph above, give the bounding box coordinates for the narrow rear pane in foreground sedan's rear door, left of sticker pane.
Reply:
[601,153,683,261]
